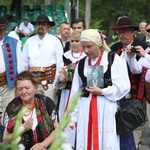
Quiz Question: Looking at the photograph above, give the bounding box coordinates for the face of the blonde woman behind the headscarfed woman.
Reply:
[70,39,82,53]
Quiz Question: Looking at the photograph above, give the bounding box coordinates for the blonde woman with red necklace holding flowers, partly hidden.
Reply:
[54,31,86,147]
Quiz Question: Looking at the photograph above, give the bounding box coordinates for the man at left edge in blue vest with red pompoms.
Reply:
[0,18,24,134]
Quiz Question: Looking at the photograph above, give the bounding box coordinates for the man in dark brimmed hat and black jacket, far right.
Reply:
[111,17,149,149]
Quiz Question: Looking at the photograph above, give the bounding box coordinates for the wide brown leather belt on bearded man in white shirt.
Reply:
[29,64,56,90]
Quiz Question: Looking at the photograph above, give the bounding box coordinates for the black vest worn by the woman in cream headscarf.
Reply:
[78,52,116,97]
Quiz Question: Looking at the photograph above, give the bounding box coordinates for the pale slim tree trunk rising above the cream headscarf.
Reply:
[85,0,92,28]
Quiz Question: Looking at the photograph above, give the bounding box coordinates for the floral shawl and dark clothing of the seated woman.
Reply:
[4,94,58,150]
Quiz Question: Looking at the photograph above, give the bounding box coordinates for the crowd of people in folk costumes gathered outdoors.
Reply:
[0,9,150,150]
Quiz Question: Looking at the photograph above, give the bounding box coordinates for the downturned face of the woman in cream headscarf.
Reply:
[81,41,101,59]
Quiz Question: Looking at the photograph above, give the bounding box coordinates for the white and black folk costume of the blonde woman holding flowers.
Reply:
[55,50,86,147]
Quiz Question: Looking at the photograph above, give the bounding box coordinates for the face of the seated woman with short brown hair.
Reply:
[16,80,37,104]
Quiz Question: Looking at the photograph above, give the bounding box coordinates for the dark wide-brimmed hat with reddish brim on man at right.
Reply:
[110,17,139,30]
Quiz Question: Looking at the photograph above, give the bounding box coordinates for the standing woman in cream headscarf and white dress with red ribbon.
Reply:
[70,29,130,150]
